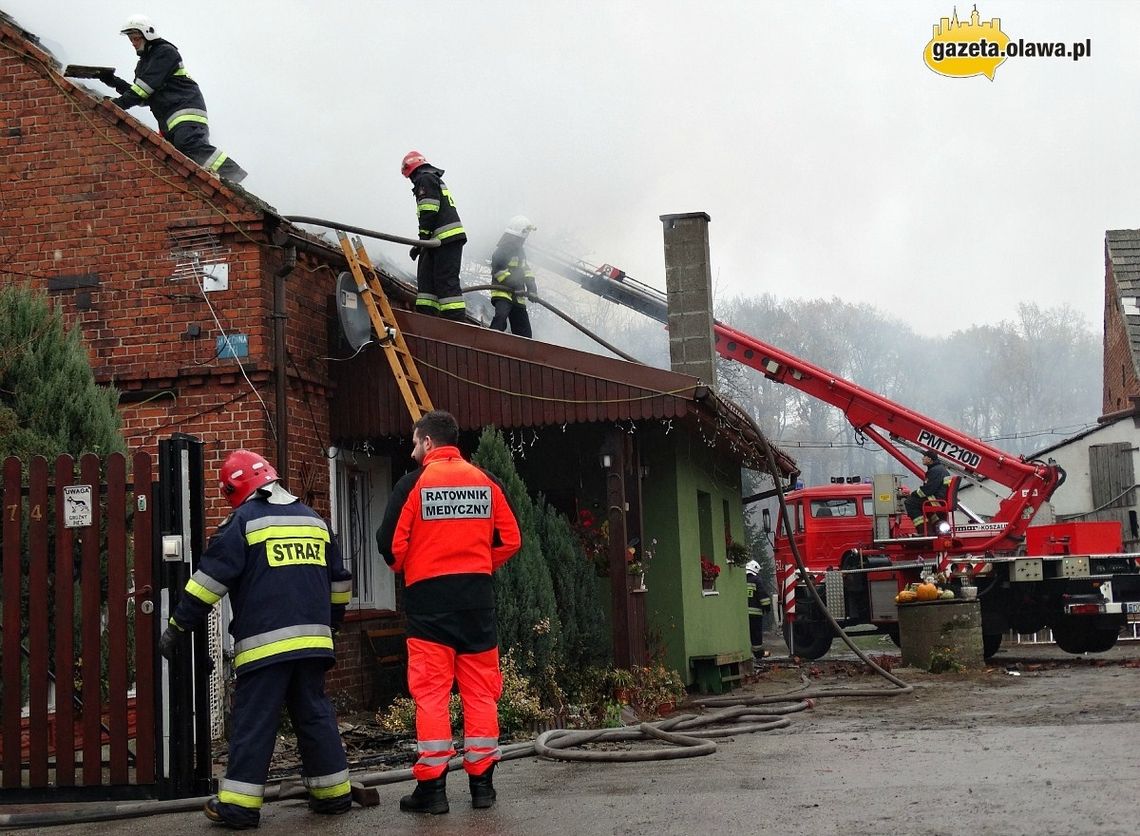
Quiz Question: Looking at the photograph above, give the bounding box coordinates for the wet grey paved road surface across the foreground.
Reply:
[8,642,1140,836]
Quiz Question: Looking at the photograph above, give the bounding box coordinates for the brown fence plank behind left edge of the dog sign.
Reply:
[55,455,75,787]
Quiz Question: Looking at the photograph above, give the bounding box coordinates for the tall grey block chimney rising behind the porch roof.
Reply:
[661,212,716,388]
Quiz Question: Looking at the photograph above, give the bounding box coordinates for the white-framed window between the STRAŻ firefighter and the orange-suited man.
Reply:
[333,453,396,610]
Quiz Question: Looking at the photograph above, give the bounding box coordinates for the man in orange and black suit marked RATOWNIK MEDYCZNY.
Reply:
[376,409,522,814]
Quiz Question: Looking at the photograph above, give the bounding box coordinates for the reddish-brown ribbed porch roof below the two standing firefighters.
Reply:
[329,311,798,476]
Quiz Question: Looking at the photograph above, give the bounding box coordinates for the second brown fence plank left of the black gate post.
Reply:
[106,453,129,784]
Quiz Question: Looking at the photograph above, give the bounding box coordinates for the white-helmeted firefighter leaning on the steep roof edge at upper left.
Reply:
[99,15,245,182]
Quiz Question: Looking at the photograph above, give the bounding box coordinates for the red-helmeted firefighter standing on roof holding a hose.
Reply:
[400,151,467,322]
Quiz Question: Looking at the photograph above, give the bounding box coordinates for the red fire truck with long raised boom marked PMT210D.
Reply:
[529,247,1140,658]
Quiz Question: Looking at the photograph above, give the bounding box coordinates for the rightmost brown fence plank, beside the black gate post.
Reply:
[131,451,158,785]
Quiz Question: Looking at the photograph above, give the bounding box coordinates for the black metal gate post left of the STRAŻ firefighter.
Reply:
[154,432,213,797]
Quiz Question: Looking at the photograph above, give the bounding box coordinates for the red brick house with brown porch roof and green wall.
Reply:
[0,14,793,703]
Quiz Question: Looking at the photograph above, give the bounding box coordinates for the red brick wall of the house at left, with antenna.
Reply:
[0,19,392,699]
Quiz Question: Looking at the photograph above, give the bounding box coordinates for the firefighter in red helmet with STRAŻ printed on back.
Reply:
[158,451,352,828]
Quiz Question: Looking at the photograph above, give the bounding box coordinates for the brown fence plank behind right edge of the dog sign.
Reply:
[75,453,103,786]
